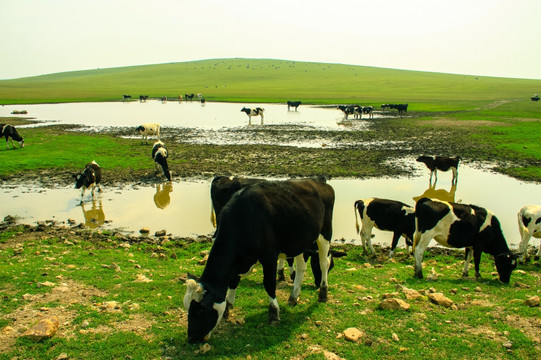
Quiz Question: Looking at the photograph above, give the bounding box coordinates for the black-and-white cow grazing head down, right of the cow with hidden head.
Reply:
[413,198,519,283]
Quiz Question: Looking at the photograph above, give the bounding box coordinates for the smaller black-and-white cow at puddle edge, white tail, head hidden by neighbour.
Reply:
[354,198,415,258]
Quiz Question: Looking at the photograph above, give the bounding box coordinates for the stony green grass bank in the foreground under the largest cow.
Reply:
[0,225,541,359]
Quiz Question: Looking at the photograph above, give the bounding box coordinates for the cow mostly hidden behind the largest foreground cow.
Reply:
[210,176,334,287]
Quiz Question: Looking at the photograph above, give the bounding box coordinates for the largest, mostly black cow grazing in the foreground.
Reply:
[184,178,334,342]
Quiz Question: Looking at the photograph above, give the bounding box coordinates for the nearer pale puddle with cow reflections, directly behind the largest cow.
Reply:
[0,165,541,248]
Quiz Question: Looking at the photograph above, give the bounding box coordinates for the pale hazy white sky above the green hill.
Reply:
[0,0,541,79]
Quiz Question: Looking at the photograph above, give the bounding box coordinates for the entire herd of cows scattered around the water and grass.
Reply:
[0,99,541,342]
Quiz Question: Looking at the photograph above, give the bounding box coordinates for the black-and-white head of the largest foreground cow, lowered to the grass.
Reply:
[184,276,226,343]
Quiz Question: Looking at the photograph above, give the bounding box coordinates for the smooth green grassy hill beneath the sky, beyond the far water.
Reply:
[0,59,541,111]
